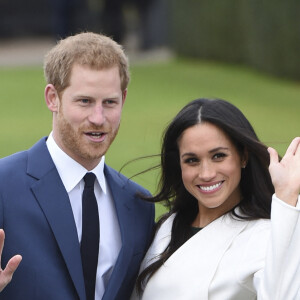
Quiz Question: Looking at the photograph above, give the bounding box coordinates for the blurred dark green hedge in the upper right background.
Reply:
[169,0,300,79]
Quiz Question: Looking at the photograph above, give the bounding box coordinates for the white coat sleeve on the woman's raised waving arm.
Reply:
[254,195,300,300]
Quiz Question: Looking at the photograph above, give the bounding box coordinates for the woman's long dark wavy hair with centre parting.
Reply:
[137,99,274,292]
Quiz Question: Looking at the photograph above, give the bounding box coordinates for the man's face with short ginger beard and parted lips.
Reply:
[46,65,126,170]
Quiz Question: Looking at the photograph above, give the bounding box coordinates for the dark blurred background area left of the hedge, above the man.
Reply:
[0,0,168,50]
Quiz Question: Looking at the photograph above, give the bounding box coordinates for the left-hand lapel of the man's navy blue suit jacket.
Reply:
[28,140,85,299]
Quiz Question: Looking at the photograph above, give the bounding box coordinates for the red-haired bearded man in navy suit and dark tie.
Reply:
[0,33,154,300]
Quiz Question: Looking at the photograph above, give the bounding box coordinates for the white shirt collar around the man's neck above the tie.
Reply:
[46,132,106,194]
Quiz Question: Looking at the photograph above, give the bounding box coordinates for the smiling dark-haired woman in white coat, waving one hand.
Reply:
[132,99,300,300]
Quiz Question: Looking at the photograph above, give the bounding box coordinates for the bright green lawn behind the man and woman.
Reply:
[0,59,300,218]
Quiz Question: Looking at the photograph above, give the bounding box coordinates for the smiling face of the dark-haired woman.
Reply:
[178,122,244,223]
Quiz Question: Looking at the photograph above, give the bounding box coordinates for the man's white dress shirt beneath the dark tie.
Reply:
[47,132,122,300]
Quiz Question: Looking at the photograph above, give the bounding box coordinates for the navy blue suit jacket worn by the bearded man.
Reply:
[0,138,154,300]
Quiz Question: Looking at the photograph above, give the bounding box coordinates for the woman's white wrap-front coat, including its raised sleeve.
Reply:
[132,195,300,300]
